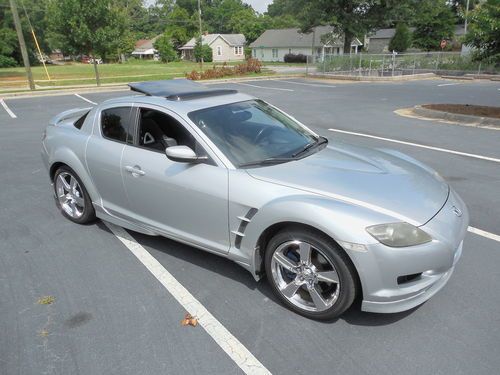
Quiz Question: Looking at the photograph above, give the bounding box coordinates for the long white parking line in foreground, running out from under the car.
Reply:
[105,223,271,374]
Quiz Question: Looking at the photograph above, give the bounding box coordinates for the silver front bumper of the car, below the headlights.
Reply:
[348,189,469,313]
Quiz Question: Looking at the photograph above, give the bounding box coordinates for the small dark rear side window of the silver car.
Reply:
[101,107,133,143]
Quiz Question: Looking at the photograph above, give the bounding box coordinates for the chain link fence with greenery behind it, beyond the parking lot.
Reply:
[308,52,500,77]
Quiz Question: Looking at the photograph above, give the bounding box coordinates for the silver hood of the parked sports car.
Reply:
[247,144,449,225]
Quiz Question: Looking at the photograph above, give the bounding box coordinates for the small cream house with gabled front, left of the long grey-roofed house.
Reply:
[179,34,246,61]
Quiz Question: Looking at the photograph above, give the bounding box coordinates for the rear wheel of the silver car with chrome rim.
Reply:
[54,166,95,224]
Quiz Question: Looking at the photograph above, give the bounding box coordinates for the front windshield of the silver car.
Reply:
[188,100,318,167]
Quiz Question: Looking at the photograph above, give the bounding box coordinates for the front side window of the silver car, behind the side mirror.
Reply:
[138,108,206,156]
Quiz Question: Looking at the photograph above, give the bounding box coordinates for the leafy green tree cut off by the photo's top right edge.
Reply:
[465,0,500,64]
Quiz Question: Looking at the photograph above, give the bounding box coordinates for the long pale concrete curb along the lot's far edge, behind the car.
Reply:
[0,73,305,99]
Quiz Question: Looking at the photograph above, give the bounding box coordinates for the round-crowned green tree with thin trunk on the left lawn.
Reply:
[47,0,128,85]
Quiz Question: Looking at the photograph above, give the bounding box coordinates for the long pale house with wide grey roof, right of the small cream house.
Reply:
[250,26,362,61]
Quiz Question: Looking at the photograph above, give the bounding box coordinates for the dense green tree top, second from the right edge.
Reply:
[413,0,456,51]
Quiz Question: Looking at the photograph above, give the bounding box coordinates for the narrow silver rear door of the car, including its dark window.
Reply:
[85,104,136,217]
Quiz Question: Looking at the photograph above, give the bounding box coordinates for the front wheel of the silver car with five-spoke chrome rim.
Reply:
[264,227,357,320]
